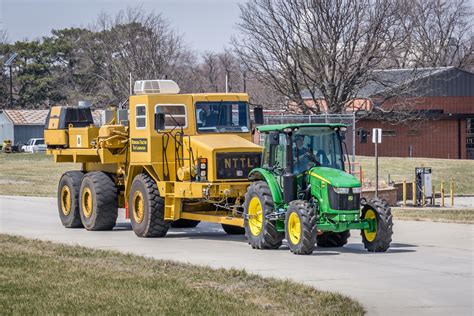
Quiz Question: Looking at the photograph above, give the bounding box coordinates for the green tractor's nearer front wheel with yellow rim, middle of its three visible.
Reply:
[285,200,318,255]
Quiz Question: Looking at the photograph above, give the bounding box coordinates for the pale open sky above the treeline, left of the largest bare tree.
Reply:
[0,0,245,51]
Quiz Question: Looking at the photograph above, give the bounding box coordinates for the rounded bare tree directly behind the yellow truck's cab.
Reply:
[84,7,189,103]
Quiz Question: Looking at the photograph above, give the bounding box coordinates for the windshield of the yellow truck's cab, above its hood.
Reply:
[196,102,250,133]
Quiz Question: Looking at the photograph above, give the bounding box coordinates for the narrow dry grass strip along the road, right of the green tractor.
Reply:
[392,207,474,224]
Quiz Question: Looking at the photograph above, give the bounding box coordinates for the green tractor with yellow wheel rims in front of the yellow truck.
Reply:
[244,124,393,255]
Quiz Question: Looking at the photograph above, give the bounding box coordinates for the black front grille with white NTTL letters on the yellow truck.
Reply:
[216,153,261,179]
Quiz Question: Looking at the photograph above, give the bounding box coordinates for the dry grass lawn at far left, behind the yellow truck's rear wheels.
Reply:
[0,153,80,196]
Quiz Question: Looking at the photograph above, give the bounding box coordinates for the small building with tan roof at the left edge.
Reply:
[0,110,48,145]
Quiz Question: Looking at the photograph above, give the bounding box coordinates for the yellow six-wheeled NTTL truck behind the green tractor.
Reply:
[45,80,262,237]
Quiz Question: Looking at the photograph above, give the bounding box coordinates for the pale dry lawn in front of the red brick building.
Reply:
[356,156,474,194]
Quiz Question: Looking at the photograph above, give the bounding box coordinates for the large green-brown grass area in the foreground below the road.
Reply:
[0,235,364,315]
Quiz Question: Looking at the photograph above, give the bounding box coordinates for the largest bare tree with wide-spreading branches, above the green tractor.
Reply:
[233,0,406,112]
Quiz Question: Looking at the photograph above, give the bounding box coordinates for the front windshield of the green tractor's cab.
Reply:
[292,127,344,174]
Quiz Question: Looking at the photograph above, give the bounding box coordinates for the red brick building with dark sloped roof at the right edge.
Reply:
[303,67,474,159]
